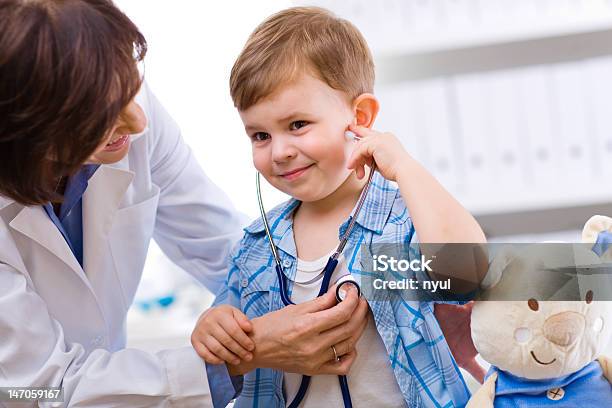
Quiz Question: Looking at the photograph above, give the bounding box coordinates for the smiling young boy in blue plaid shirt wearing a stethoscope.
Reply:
[194,8,485,407]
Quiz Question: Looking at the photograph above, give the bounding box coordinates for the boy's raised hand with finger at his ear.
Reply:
[348,125,411,182]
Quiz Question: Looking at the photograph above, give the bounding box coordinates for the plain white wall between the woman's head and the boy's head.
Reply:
[115,0,296,218]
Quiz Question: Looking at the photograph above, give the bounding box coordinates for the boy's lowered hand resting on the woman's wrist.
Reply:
[191,305,255,365]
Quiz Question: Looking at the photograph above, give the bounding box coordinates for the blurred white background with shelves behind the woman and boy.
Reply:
[116,0,612,388]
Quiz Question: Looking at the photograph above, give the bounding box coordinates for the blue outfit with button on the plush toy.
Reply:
[487,361,612,408]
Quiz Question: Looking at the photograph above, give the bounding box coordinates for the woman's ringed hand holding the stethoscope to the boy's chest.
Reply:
[227,287,368,375]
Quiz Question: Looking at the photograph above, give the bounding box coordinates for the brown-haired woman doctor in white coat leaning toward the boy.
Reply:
[0,0,366,407]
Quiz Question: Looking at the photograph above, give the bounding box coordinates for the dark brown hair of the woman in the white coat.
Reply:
[0,0,147,205]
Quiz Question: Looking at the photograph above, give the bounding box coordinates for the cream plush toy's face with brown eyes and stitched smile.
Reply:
[472,298,612,379]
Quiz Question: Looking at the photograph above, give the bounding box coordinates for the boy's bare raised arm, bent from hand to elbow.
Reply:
[349,125,488,294]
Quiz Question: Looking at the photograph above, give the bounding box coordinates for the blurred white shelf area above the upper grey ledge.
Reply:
[302,0,612,57]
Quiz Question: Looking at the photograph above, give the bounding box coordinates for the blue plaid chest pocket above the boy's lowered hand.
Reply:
[238,267,275,319]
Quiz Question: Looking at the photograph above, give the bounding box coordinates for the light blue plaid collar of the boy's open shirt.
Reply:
[244,172,399,253]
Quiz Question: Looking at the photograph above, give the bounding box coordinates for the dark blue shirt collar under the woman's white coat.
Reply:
[43,164,100,267]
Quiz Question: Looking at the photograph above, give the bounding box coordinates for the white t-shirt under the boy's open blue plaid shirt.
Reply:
[284,252,406,408]
